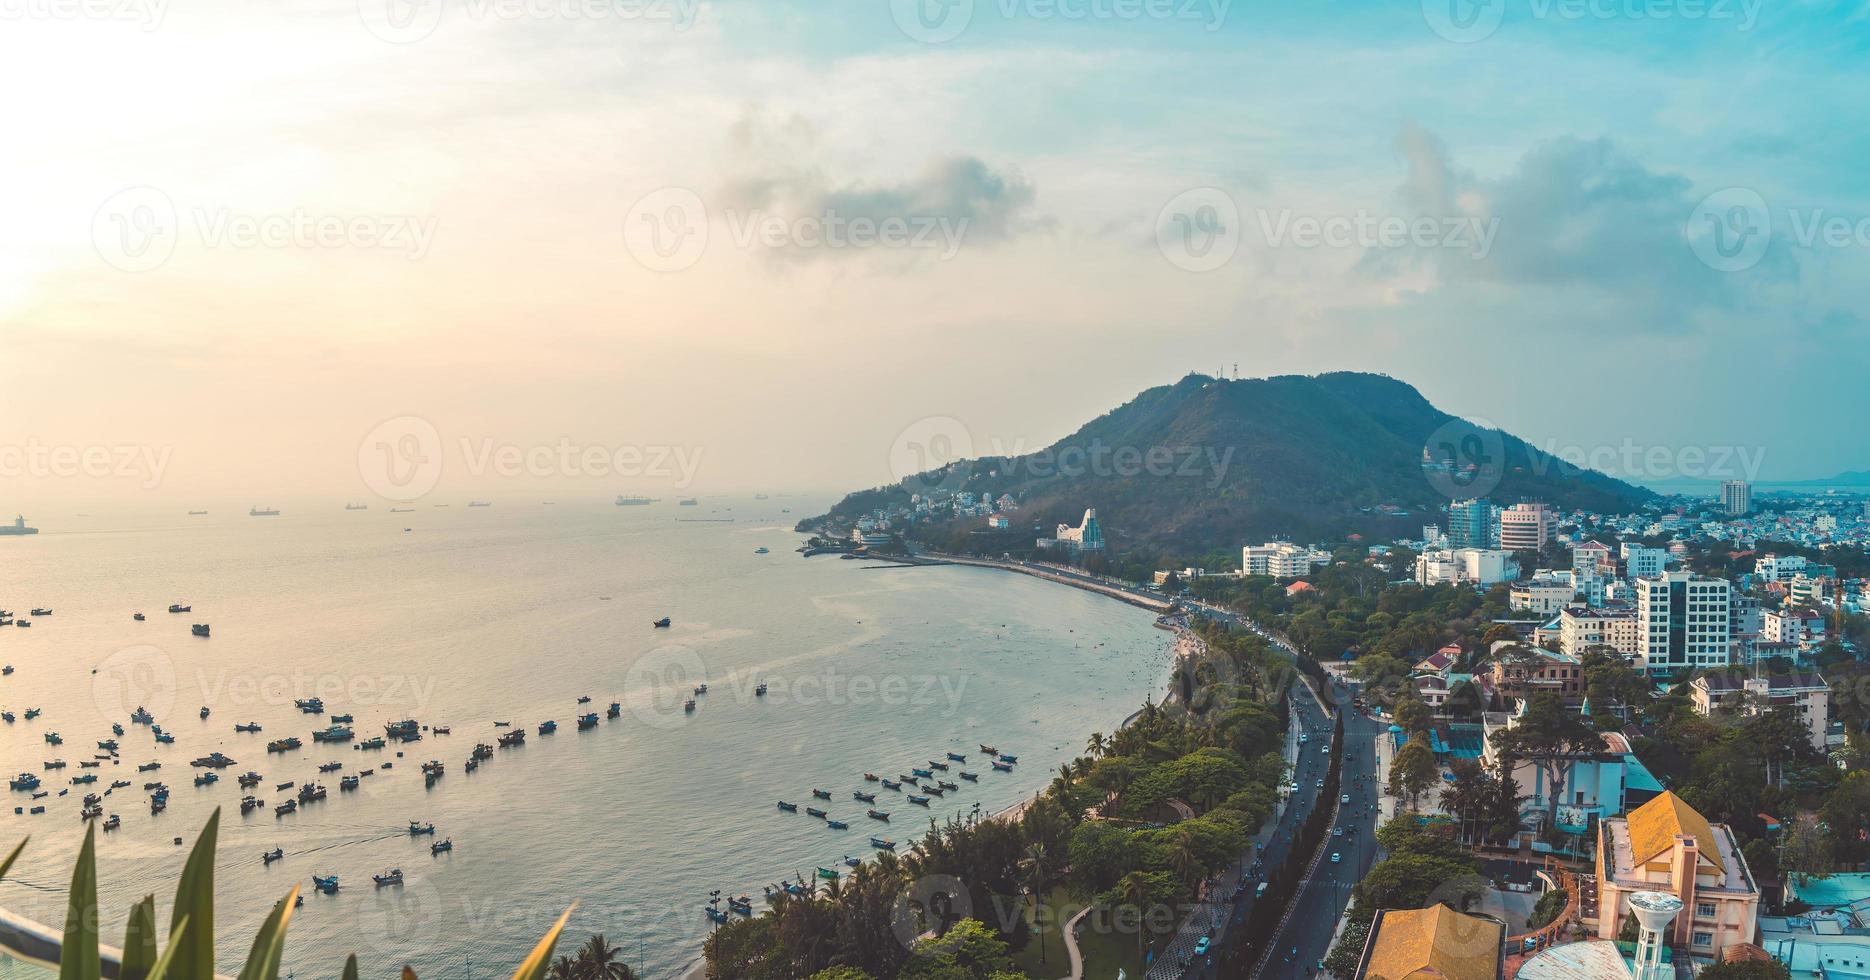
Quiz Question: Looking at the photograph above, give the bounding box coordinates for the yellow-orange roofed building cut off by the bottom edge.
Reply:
[1358,905,1507,980]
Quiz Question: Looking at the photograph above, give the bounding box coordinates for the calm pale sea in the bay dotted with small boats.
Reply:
[0,497,1169,978]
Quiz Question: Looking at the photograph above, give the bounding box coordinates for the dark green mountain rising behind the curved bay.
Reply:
[802,372,1655,554]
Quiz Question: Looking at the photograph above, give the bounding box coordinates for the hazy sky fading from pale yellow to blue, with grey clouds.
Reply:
[0,0,1870,511]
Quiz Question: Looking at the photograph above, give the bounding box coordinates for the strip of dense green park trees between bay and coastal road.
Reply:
[705,628,1292,980]
